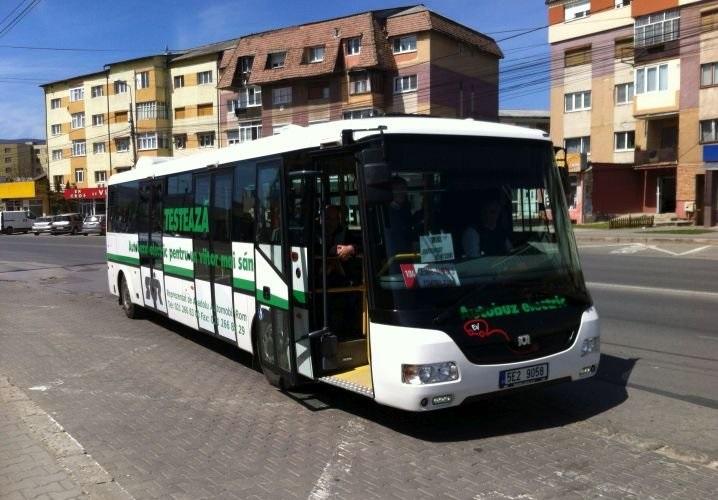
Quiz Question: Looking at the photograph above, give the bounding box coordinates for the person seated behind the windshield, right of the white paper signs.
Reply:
[461,193,511,258]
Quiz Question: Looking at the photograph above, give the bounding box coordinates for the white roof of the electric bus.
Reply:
[108,116,550,184]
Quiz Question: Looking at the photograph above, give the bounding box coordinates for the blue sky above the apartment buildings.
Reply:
[0,0,549,139]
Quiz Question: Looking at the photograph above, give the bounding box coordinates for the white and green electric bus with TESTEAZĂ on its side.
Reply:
[107,117,600,411]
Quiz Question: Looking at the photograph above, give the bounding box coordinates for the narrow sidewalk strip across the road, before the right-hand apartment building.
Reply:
[573,227,718,245]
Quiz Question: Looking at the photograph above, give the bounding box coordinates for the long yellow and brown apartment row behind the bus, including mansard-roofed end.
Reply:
[41,6,502,213]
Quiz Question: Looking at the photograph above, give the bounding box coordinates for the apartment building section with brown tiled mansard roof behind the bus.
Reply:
[219,6,502,137]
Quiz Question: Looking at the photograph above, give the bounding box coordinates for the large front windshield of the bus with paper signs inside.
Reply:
[367,135,590,312]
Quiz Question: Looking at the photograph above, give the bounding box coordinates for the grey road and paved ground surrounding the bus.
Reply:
[0,236,718,500]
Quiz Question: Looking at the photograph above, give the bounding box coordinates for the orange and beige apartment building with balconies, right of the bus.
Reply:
[546,0,718,225]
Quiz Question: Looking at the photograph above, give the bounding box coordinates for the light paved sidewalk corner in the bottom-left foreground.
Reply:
[0,376,131,500]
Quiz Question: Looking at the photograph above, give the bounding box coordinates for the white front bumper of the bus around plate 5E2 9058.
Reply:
[371,308,600,411]
